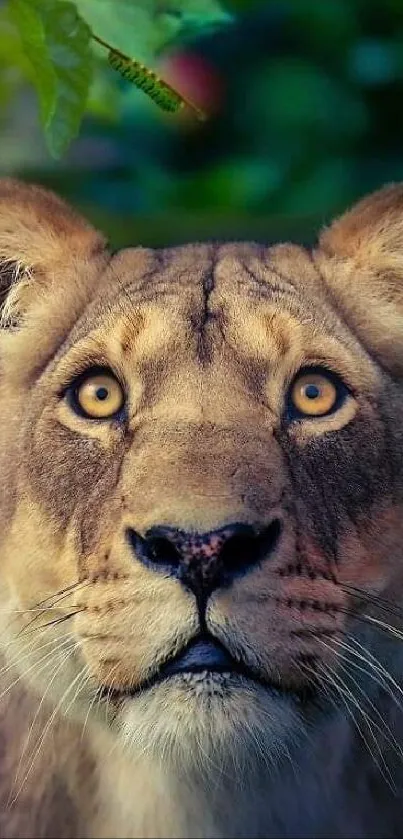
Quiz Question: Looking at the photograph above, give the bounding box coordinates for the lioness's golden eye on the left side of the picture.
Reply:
[75,373,124,419]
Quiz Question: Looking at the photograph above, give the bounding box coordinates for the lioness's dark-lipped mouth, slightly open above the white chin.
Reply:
[105,634,312,703]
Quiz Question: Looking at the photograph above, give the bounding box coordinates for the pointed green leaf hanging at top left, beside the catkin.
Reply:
[9,0,92,157]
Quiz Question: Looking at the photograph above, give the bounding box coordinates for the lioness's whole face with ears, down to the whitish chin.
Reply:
[0,182,403,776]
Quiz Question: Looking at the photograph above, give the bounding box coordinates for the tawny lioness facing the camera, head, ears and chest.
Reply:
[0,180,403,839]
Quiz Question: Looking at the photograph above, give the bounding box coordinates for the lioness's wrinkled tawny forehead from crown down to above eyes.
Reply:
[69,243,351,368]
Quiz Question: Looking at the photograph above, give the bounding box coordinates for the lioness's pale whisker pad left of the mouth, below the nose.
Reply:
[75,569,198,690]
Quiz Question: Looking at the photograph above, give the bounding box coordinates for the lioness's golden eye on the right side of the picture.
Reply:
[290,371,339,417]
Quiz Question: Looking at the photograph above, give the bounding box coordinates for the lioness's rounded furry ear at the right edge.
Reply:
[314,184,403,376]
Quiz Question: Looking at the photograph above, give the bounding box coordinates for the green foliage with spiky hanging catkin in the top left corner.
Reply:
[5,0,231,157]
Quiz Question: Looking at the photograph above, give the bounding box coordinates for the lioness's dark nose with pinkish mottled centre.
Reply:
[128,519,281,600]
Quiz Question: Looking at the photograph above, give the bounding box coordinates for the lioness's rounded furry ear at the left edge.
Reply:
[0,178,105,326]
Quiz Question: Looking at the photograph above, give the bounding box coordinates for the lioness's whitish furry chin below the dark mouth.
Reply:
[110,671,301,772]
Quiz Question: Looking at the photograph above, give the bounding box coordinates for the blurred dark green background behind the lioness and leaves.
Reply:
[0,0,403,247]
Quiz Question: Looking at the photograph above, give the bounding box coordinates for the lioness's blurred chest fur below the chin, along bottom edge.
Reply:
[0,677,403,839]
